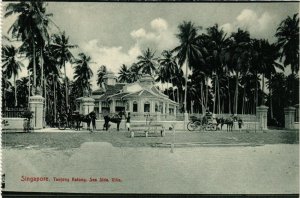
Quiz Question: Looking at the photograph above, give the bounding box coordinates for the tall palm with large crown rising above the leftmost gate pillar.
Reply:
[4,1,51,92]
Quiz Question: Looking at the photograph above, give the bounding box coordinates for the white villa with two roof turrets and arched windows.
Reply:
[83,72,179,120]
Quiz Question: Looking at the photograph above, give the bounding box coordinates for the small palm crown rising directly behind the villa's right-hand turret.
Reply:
[137,48,157,75]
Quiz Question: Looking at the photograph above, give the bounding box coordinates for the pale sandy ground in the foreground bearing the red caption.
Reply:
[2,142,299,194]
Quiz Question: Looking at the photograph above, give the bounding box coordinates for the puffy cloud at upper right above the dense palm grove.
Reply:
[221,9,277,39]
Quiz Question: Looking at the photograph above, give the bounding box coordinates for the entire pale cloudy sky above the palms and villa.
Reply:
[2,2,299,89]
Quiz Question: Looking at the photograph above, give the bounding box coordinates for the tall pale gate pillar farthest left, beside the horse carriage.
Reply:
[29,95,44,129]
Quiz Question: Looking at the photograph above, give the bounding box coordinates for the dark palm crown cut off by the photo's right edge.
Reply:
[275,13,299,73]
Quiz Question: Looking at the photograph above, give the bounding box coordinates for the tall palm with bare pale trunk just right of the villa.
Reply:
[173,21,202,116]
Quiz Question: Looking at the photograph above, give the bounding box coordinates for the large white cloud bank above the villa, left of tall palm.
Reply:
[79,18,178,89]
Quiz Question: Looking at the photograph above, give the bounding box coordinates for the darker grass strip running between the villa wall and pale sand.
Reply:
[2,130,299,149]
